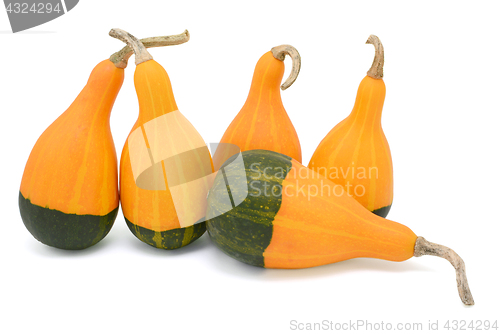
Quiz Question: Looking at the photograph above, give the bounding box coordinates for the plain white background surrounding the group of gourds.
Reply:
[0,0,500,333]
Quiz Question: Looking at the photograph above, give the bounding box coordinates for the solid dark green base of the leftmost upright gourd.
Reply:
[19,192,118,250]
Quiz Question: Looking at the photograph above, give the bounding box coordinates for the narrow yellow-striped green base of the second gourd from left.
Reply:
[125,217,207,249]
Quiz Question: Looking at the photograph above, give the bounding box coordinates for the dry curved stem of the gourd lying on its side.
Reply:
[413,237,474,305]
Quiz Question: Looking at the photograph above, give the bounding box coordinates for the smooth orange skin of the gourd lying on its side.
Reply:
[264,160,417,269]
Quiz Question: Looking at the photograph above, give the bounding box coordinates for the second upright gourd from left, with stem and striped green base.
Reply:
[110,29,213,249]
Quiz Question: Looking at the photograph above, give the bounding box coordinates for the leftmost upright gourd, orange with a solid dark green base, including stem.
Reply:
[19,31,187,249]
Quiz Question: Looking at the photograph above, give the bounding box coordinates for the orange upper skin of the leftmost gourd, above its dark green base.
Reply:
[20,60,124,216]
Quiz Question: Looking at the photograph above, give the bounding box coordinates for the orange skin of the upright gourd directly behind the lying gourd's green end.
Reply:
[214,51,302,169]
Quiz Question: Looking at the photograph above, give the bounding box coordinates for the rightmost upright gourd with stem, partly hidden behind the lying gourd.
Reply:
[308,35,393,217]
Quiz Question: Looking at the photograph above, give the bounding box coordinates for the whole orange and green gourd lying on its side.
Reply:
[206,150,474,305]
